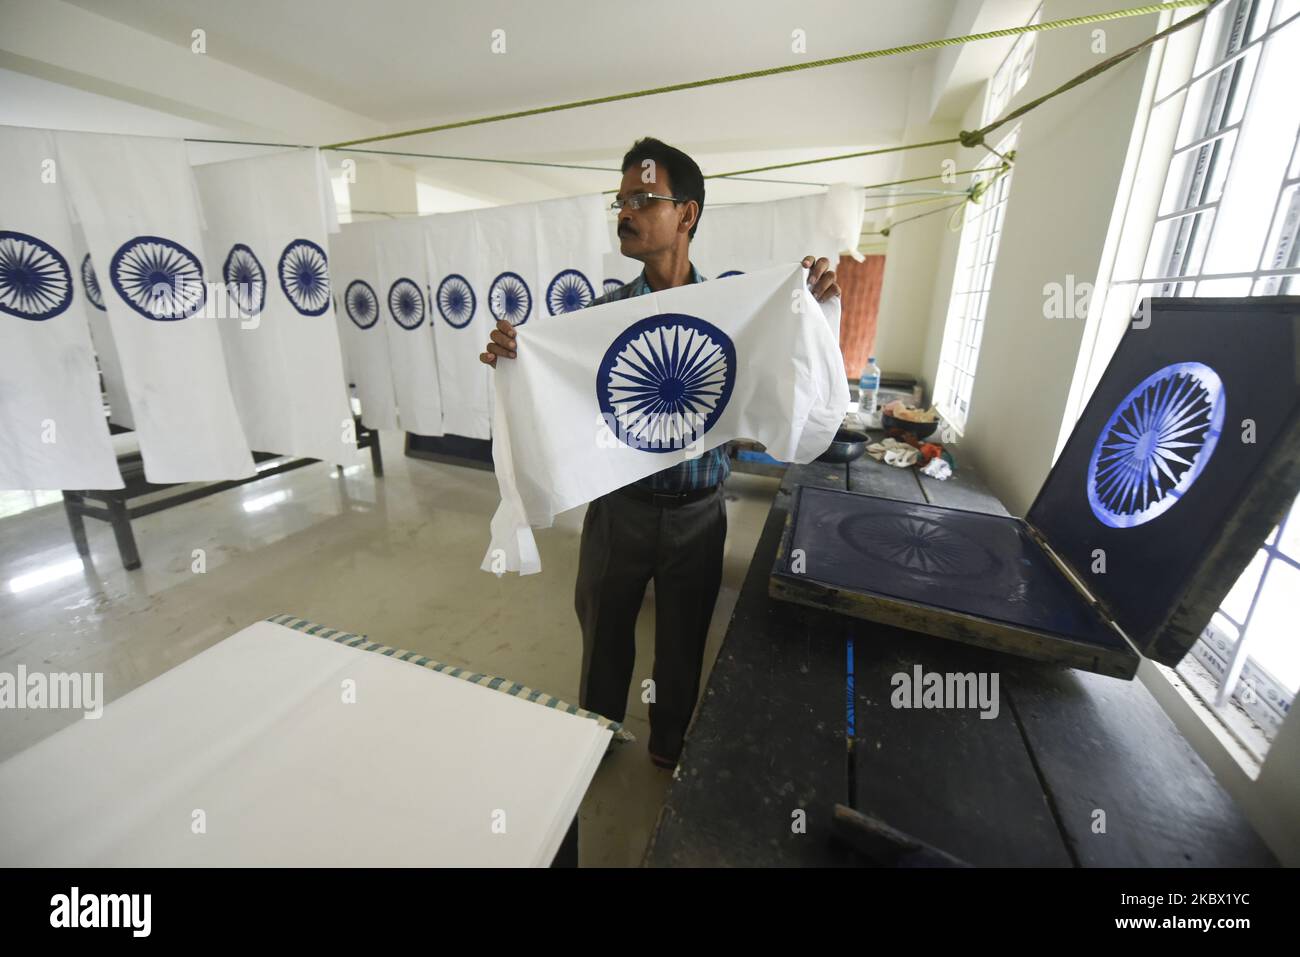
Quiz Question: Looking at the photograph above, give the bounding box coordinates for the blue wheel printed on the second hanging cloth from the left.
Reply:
[108,235,207,322]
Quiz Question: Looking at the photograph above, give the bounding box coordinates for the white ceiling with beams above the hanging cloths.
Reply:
[0,0,1024,218]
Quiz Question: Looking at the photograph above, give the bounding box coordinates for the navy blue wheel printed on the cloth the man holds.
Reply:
[595,312,736,452]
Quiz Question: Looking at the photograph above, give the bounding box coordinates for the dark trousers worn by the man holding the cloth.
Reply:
[573,486,727,761]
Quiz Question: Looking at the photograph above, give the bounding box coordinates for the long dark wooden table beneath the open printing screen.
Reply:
[644,442,1277,867]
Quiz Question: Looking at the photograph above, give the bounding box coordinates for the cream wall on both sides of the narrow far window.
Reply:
[876,0,1156,515]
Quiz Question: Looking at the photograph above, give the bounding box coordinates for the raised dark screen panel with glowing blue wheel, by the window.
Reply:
[1028,296,1300,648]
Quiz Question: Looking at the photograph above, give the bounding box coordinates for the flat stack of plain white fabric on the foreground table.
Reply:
[0,622,611,867]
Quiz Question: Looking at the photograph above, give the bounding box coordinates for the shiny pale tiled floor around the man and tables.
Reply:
[0,433,777,866]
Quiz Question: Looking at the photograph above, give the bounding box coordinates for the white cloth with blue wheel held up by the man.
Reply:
[481,265,849,575]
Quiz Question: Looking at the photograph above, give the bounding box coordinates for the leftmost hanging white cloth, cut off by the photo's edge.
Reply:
[0,126,122,489]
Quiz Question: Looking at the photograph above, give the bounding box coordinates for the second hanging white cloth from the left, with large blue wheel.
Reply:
[55,133,255,482]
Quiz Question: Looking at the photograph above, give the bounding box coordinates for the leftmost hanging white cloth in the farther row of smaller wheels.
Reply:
[329,222,398,429]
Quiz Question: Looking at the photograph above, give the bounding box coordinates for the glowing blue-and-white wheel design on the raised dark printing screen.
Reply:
[1088,363,1227,528]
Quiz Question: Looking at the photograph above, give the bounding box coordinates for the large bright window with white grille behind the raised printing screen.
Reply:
[1088,0,1300,757]
